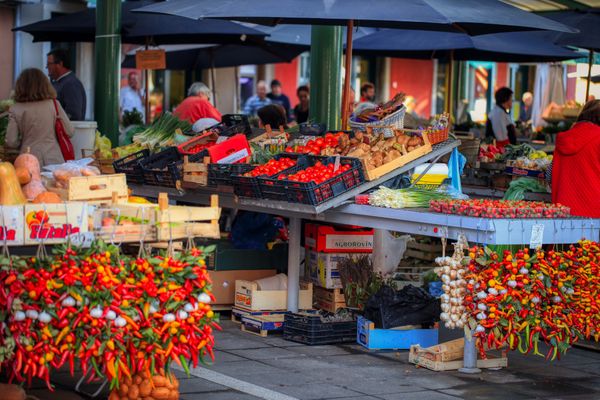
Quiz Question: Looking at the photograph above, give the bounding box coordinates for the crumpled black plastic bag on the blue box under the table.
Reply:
[365,285,441,329]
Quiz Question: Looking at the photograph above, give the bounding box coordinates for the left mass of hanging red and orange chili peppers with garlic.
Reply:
[0,242,218,388]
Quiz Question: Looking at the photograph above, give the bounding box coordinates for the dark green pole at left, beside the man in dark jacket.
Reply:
[95,0,121,146]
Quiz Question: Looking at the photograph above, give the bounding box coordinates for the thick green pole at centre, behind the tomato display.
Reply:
[309,26,343,130]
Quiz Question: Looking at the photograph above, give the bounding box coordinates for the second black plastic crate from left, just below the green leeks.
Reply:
[140,147,202,188]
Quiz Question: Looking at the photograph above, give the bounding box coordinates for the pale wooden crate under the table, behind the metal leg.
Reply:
[234,280,313,311]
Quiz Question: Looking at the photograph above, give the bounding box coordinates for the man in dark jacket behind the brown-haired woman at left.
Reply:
[46,49,86,121]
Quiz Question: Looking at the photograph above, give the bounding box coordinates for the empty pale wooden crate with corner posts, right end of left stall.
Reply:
[156,193,221,241]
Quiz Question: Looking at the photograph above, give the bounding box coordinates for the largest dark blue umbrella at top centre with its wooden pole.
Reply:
[137,0,576,124]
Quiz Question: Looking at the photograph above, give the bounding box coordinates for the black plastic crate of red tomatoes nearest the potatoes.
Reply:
[258,156,365,206]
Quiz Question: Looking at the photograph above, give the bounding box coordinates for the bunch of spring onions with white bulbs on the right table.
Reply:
[369,186,449,208]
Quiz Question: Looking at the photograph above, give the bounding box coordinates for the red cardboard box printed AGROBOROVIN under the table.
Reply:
[304,223,373,253]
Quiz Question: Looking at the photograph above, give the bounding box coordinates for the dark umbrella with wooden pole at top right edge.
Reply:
[544,9,600,101]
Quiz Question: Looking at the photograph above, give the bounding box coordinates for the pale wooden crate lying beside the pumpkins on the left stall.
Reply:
[48,174,129,205]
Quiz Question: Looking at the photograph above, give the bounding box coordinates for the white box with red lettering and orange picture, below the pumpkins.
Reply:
[24,202,88,245]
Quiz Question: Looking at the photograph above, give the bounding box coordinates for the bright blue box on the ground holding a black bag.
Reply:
[356,317,438,350]
